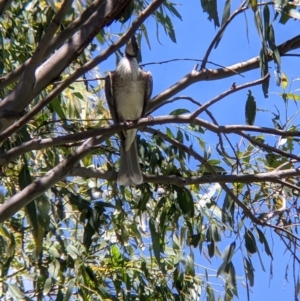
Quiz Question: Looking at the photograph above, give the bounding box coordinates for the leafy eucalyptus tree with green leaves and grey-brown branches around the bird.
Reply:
[0,0,300,301]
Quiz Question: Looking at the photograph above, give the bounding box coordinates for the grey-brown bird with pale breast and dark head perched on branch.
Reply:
[105,36,153,186]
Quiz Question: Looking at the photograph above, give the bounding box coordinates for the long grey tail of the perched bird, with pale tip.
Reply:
[117,139,143,186]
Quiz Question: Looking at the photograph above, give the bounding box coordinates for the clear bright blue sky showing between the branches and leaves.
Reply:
[99,0,300,301]
